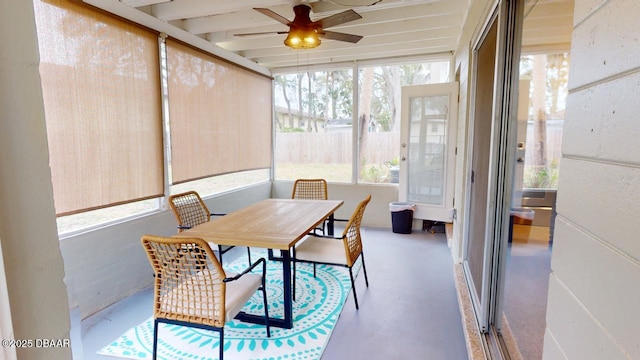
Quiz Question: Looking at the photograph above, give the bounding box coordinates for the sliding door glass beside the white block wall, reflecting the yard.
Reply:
[502,51,570,359]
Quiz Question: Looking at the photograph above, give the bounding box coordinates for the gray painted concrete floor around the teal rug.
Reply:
[81,228,468,360]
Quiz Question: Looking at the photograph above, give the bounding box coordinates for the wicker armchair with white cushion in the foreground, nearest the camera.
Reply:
[141,235,271,360]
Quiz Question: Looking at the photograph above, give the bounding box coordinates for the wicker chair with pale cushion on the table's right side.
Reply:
[293,195,371,309]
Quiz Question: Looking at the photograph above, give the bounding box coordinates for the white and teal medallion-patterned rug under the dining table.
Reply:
[98,252,357,360]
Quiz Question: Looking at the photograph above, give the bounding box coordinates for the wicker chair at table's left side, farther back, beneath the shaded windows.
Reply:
[169,191,251,264]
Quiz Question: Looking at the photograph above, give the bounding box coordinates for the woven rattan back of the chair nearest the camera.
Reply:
[142,235,226,327]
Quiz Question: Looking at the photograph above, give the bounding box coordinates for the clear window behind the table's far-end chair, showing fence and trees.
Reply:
[274,69,353,182]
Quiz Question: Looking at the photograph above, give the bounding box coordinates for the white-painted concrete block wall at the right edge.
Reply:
[544,0,640,359]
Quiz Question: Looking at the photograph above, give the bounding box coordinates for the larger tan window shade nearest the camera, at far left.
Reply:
[34,0,164,215]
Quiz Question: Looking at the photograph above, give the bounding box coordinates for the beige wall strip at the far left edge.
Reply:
[0,0,71,359]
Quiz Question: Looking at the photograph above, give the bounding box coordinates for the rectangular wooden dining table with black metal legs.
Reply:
[175,199,343,329]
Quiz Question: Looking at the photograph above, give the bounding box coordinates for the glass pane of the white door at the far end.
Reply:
[407,95,449,206]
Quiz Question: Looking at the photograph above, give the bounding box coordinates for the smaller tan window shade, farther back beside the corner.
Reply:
[166,40,272,184]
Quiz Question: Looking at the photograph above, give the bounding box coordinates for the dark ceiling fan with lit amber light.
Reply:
[236,4,362,49]
